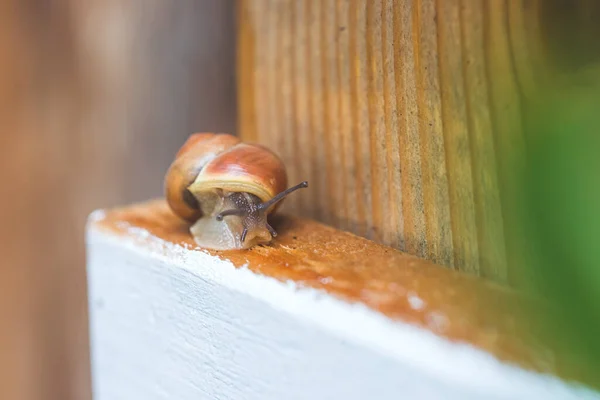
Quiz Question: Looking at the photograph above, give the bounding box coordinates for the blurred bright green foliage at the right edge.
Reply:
[514,69,600,387]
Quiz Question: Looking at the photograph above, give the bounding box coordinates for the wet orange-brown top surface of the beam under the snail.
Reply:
[91,200,596,390]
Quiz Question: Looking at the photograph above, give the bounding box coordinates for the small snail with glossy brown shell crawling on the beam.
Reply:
[164,133,308,250]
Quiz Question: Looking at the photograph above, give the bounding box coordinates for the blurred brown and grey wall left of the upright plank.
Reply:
[0,0,236,400]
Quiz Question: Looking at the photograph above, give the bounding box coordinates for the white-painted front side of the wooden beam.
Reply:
[87,223,600,400]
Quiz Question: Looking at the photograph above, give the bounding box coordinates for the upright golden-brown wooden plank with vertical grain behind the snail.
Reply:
[238,0,550,281]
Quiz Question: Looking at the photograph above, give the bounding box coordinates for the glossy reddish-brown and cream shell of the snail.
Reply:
[165,133,287,222]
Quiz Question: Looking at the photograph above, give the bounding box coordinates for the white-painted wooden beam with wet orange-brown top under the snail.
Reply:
[87,200,600,400]
